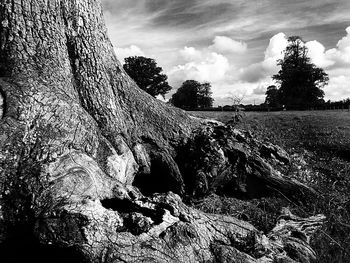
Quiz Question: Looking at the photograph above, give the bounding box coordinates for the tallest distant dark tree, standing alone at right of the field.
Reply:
[273,36,329,109]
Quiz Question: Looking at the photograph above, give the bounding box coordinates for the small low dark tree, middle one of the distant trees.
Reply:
[170,80,214,109]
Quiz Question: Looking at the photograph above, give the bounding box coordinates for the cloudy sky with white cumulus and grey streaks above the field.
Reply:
[102,0,350,105]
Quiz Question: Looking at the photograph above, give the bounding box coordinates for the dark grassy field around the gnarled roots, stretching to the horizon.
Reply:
[190,111,350,263]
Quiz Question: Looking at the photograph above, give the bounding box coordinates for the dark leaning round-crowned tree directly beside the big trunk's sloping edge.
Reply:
[123,56,171,98]
